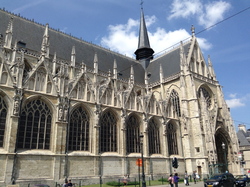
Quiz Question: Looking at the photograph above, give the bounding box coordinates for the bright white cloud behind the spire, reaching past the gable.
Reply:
[101,16,212,57]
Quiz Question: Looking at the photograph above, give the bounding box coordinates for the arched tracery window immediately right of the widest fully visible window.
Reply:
[68,107,89,151]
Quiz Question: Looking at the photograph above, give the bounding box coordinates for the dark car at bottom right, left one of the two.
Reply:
[204,173,235,187]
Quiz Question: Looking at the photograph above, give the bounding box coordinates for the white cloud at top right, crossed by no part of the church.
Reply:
[168,0,231,28]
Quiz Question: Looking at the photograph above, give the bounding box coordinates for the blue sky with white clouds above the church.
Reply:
[0,0,250,130]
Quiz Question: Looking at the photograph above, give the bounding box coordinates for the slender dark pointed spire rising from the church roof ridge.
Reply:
[135,8,154,69]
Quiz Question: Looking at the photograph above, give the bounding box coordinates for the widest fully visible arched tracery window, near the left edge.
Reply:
[17,100,52,149]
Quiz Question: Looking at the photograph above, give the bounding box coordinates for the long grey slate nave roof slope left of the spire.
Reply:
[0,10,145,84]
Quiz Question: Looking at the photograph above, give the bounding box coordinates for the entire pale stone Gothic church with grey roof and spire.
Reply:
[0,6,239,185]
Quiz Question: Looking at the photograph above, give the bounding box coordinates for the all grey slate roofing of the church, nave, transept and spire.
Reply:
[0,10,190,85]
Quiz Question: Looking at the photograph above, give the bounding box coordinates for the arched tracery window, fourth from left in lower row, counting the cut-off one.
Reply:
[100,111,117,152]
